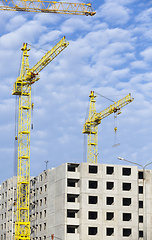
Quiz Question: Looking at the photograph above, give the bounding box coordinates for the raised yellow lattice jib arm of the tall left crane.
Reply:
[25,37,69,83]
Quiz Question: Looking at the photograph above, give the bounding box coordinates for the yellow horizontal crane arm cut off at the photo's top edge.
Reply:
[0,0,96,16]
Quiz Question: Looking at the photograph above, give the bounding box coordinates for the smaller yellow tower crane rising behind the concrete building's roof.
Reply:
[82,91,134,163]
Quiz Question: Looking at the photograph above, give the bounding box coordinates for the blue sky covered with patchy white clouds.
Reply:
[0,0,152,182]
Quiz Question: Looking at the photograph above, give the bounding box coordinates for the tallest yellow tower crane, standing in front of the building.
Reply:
[12,37,69,240]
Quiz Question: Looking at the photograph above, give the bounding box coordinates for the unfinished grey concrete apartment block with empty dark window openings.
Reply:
[0,163,152,240]
